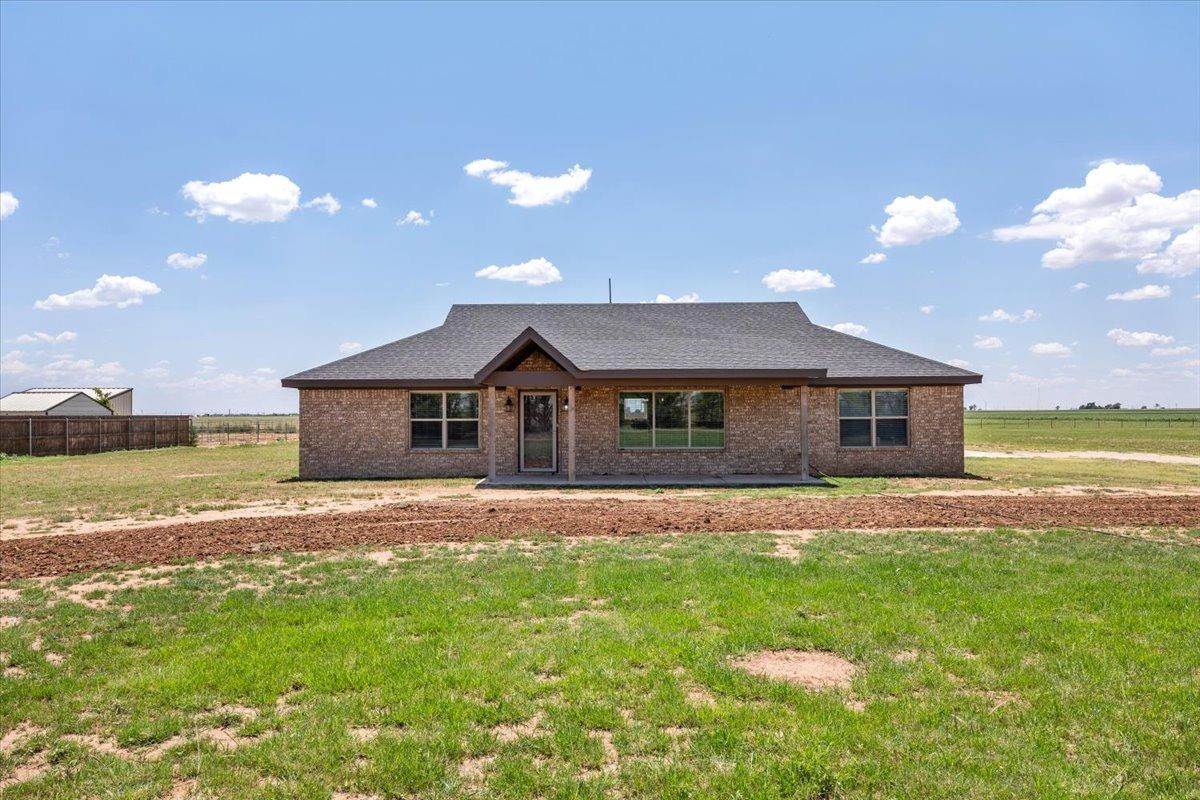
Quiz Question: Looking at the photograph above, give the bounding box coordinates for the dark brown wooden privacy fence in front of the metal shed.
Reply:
[0,415,192,456]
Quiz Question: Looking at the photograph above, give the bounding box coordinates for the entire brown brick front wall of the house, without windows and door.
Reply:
[300,383,962,479]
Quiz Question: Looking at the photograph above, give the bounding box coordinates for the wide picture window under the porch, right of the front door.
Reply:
[617,392,725,450]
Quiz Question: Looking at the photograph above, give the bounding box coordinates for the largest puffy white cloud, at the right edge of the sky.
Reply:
[992,162,1200,271]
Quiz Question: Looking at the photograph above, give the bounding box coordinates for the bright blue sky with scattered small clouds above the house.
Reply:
[0,2,1200,413]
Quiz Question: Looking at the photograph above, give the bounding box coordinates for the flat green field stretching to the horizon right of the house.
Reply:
[964,409,1200,456]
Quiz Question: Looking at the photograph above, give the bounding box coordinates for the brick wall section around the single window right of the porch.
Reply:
[809,386,962,475]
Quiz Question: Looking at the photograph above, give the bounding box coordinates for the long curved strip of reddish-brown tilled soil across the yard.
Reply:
[0,495,1200,581]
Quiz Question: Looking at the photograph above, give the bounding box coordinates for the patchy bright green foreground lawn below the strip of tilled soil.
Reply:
[0,530,1200,800]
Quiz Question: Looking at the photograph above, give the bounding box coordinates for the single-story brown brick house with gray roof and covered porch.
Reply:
[283,302,982,485]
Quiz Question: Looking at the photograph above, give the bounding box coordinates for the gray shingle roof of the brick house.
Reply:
[283,302,980,386]
